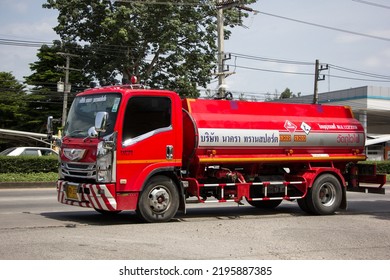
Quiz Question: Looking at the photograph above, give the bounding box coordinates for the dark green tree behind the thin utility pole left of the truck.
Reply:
[24,41,91,132]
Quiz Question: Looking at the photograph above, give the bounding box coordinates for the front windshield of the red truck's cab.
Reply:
[63,93,121,138]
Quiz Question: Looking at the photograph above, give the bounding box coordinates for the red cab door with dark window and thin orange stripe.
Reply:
[117,95,182,191]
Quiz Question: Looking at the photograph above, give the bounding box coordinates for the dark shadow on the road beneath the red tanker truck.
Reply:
[41,201,390,227]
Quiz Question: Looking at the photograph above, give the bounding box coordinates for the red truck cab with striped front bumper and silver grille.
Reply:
[50,86,183,222]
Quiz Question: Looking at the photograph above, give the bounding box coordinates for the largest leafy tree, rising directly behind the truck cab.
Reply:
[43,0,256,97]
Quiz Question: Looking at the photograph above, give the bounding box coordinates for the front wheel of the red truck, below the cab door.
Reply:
[136,176,179,223]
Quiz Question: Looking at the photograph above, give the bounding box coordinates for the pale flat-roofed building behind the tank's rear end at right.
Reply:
[274,86,390,160]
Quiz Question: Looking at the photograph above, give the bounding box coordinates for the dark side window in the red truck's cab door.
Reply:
[122,96,171,142]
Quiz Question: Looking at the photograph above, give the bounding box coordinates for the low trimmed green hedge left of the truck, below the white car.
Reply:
[0,156,59,173]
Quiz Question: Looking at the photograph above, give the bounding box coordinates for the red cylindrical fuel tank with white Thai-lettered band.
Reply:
[182,99,365,164]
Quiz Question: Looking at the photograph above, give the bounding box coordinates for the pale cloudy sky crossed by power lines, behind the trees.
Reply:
[0,0,390,99]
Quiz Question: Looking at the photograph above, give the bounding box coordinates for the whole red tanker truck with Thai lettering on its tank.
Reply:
[48,85,386,222]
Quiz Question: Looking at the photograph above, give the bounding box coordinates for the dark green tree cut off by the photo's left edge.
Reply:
[0,72,28,129]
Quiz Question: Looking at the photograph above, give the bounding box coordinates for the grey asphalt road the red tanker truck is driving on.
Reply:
[0,187,390,260]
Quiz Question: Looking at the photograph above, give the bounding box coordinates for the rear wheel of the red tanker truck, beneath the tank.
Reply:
[306,174,342,215]
